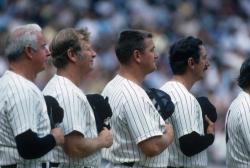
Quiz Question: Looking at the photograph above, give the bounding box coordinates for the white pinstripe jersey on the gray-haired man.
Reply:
[0,71,50,168]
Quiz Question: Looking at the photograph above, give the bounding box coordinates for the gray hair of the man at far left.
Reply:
[5,24,42,61]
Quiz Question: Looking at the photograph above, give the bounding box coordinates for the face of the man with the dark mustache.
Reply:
[194,45,209,80]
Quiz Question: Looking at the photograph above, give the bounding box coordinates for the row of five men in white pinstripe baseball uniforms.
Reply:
[0,24,250,168]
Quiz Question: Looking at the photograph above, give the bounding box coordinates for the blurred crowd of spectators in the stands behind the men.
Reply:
[0,0,250,164]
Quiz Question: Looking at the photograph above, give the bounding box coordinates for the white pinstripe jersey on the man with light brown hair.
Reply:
[43,75,101,167]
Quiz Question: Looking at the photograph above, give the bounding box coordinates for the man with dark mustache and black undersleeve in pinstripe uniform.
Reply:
[161,37,214,168]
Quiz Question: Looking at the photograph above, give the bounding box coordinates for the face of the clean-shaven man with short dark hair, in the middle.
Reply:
[142,38,158,73]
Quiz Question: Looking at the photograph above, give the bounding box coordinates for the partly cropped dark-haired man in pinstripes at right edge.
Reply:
[225,58,250,168]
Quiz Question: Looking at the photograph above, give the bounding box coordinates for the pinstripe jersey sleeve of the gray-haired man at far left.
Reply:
[7,85,41,136]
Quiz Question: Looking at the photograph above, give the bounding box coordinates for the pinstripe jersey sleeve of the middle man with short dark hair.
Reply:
[124,87,165,143]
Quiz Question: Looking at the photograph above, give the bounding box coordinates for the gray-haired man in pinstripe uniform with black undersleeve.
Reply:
[0,24,64,168]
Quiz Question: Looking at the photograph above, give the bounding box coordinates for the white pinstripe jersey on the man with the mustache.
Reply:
[161,81,208,168]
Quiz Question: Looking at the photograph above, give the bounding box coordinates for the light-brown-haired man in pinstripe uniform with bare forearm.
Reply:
[43,28,112,168]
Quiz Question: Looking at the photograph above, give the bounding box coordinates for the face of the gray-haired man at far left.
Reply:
[32,32,50,73]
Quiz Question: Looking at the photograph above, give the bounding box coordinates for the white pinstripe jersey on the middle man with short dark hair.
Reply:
[102,75,168,168]
